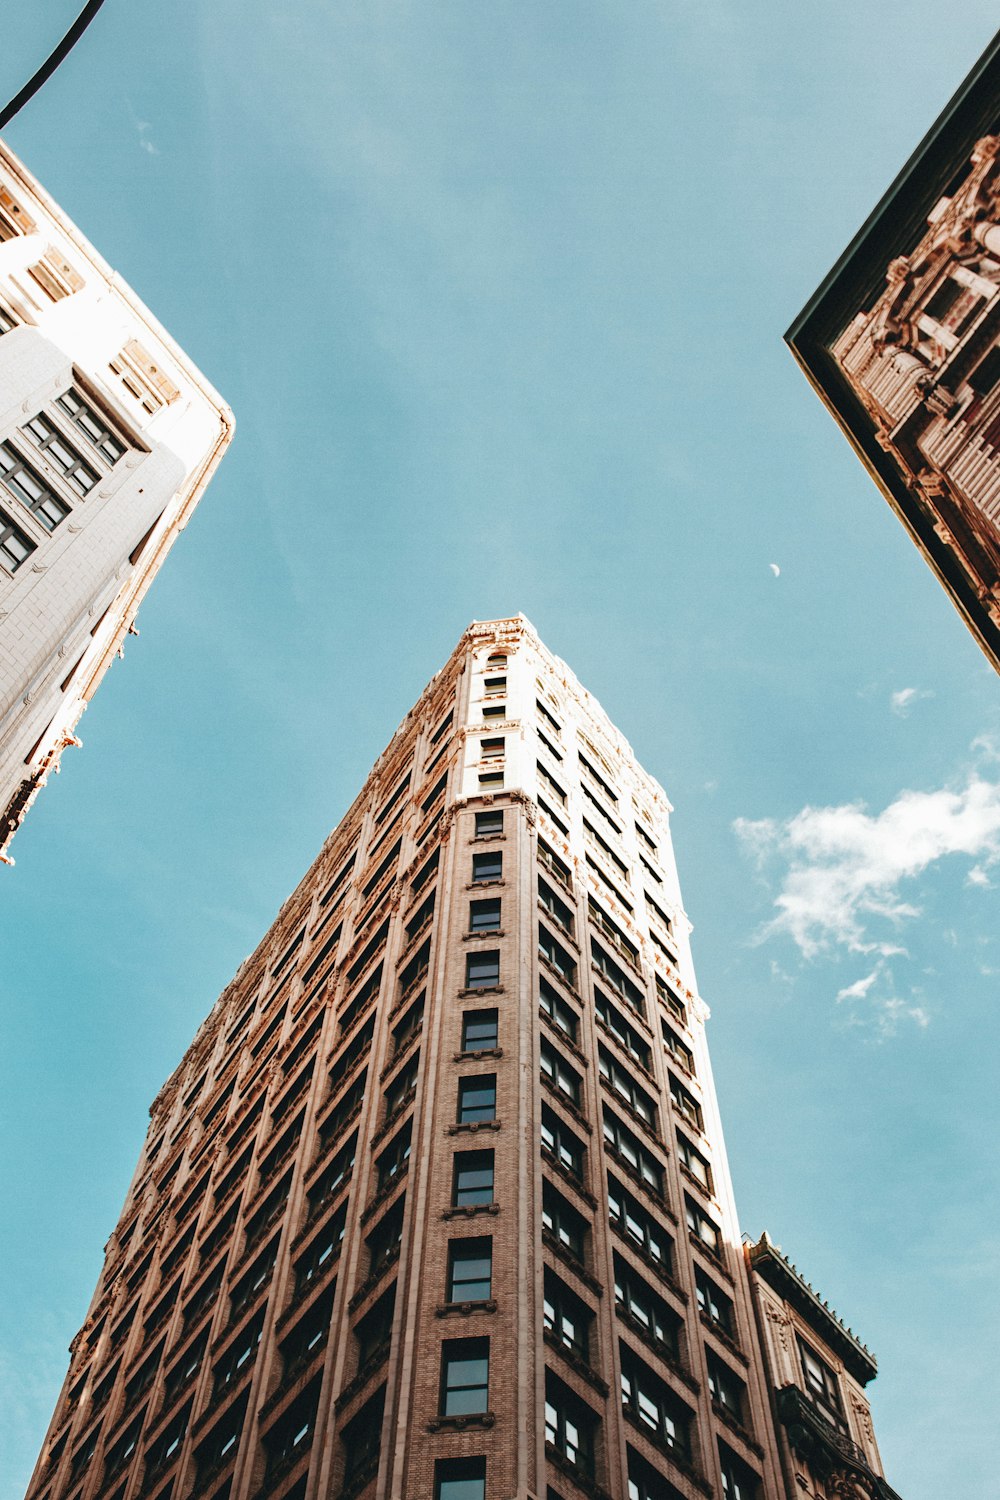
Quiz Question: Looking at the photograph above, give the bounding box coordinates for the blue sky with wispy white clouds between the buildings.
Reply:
[0,0,1000,1500]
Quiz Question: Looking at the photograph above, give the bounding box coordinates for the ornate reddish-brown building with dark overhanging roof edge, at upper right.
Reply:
[789,27,1000,669]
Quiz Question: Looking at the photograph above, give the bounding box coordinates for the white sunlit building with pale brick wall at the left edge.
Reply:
[0,144,232,863]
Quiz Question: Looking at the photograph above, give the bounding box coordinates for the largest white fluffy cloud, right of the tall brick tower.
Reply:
[733,773,1000,959]
